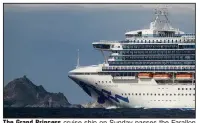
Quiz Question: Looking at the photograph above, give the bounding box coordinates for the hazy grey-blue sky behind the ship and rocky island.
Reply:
[4,4,195,103]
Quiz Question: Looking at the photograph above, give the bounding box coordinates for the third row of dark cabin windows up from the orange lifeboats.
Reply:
[113,55,195,60]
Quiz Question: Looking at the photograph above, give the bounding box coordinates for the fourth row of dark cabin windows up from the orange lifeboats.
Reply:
[112,50,195,55]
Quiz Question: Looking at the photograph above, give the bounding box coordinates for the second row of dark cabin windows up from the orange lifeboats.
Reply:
[108,61,195,65]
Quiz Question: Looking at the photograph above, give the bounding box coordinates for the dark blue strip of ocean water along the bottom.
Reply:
[4,108,195,118]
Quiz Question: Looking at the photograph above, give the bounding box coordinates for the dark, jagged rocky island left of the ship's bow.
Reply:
[3,76,82,108]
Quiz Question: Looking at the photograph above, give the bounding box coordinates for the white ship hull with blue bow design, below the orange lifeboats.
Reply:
[70,75,195,109]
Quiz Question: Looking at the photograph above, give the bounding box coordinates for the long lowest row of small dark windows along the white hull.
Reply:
[122,93,195,96]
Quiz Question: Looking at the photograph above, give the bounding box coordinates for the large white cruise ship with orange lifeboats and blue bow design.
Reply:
[68,8,195,109]
